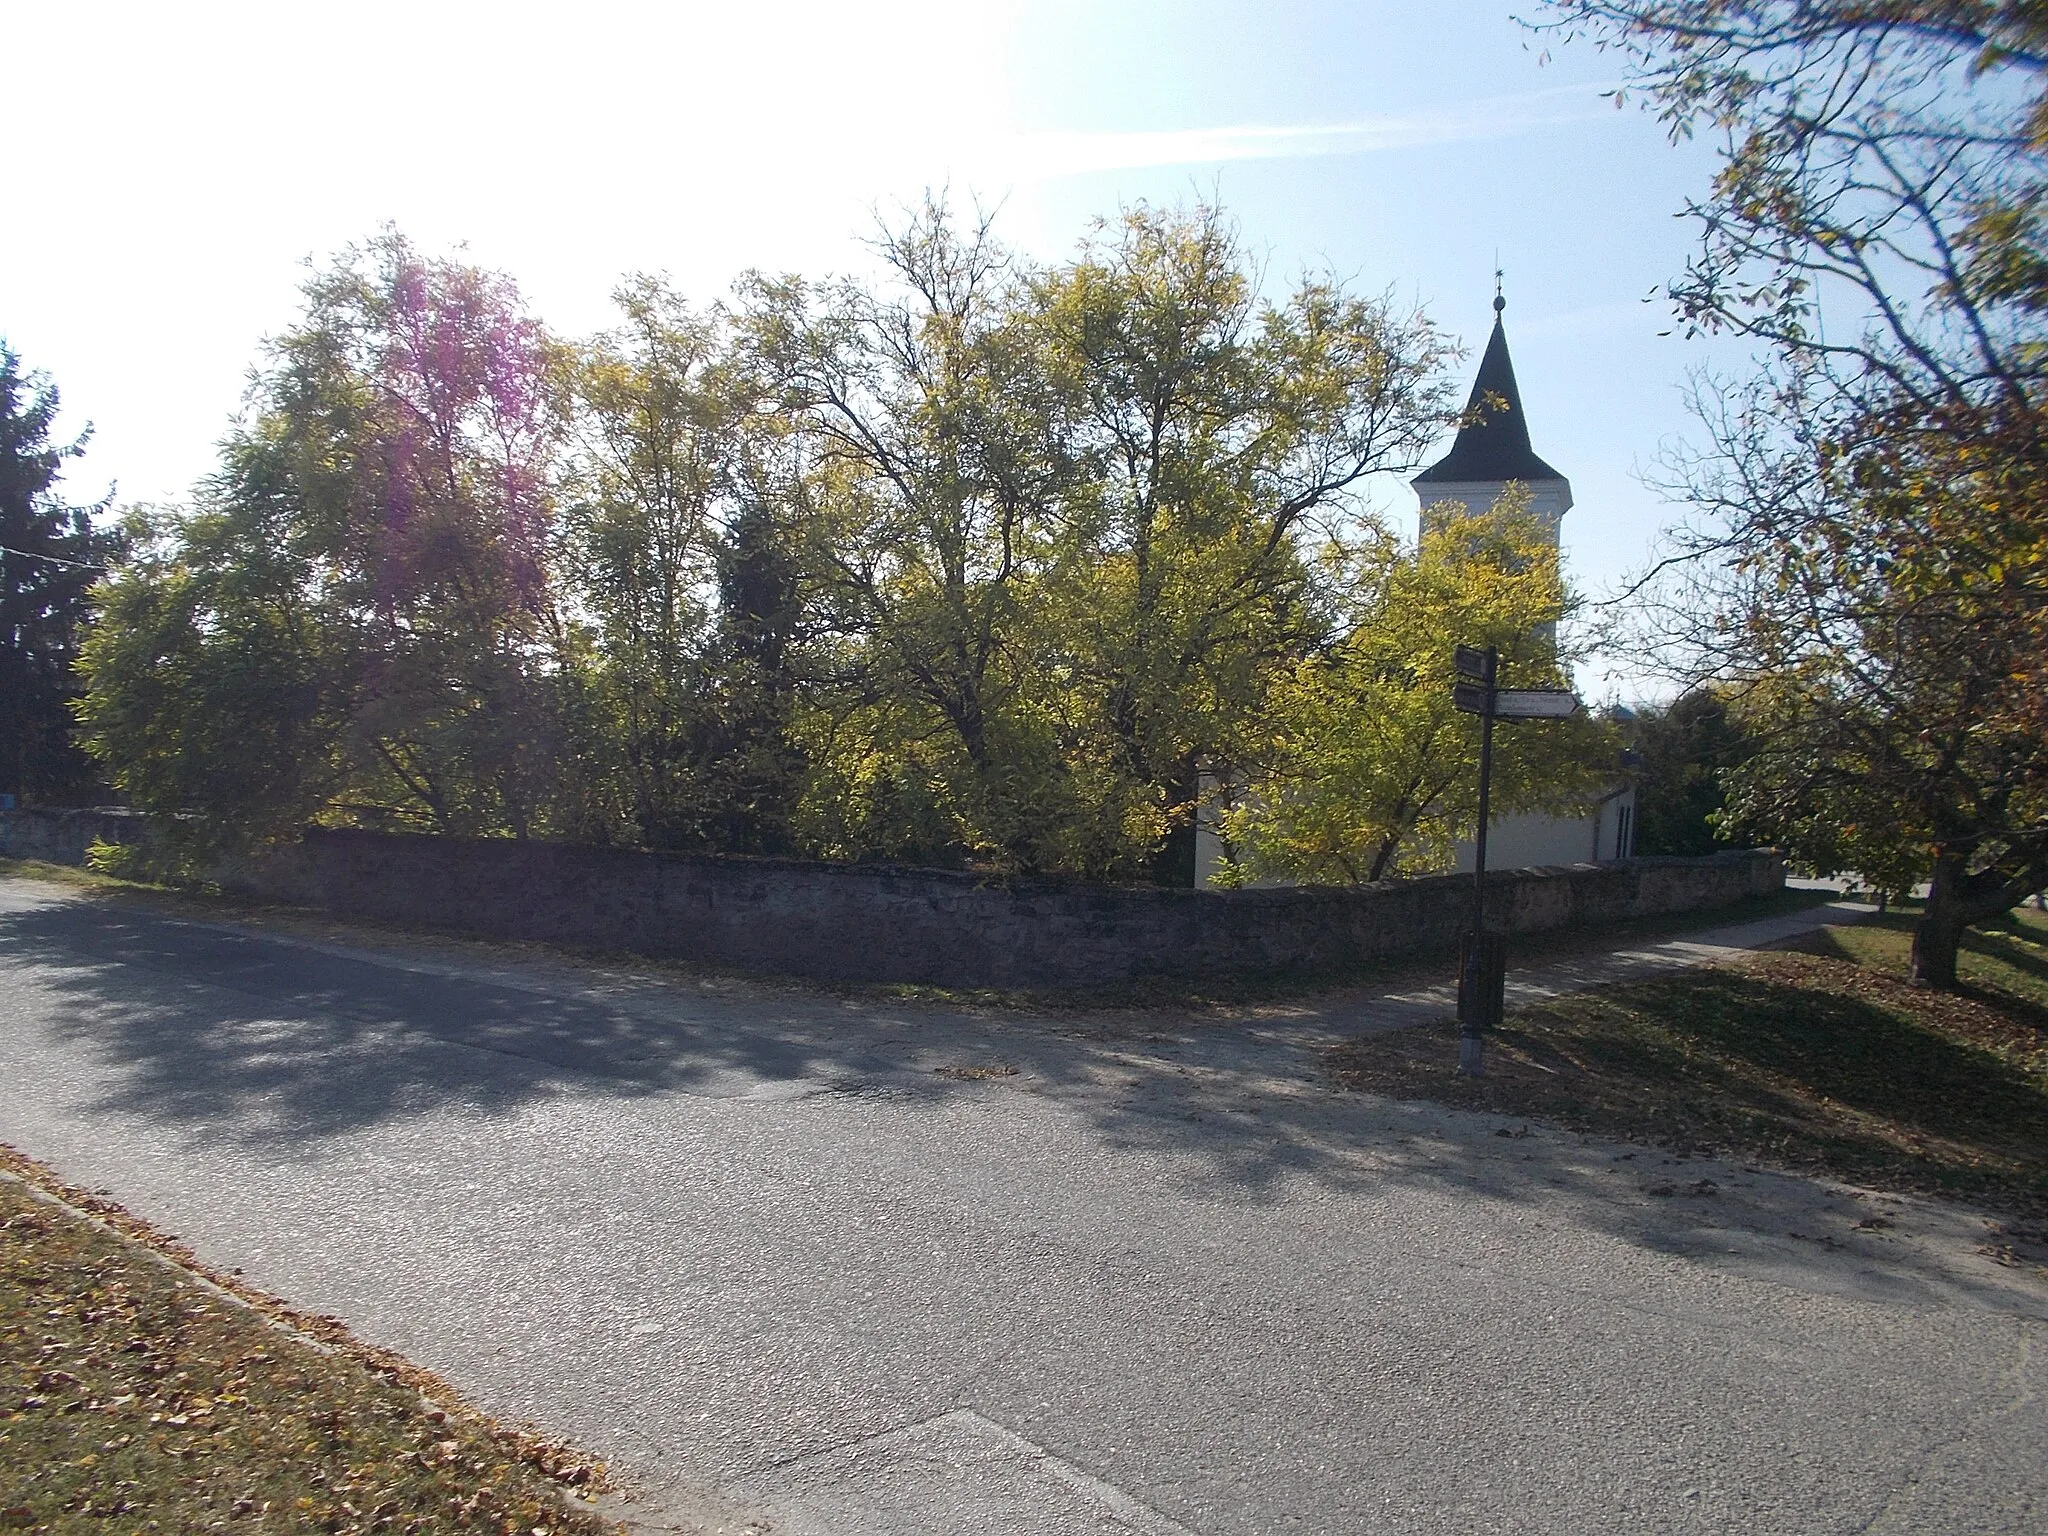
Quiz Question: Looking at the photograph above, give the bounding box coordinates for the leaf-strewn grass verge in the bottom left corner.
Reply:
[0,1149,616,1536]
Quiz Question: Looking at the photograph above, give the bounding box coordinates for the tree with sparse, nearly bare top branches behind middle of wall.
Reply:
[745,199,1069,868]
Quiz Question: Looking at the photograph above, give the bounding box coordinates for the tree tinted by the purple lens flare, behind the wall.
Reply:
[296,233,561,836]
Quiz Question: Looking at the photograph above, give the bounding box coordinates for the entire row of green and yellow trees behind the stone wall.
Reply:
[82,210,1612,885]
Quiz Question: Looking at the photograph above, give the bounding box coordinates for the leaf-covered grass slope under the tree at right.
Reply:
[1327,911,2048,1217]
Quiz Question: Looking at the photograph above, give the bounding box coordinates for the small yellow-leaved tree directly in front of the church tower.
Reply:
[1223,499,1620,885]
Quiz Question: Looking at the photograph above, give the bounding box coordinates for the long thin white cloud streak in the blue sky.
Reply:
[987,84,1612,180]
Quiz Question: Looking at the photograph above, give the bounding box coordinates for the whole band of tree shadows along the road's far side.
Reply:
[0,883,2042,1311]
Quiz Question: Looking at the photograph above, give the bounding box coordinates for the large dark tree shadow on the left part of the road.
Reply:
[0,899,937,1141]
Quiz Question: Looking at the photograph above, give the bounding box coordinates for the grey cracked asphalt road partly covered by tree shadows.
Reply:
[0,879,2048,1536]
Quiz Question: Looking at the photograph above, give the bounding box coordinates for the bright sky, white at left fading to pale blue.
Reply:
[0,0,1753,694]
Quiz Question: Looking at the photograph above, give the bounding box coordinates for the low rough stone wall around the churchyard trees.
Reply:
[0,811,1784,987]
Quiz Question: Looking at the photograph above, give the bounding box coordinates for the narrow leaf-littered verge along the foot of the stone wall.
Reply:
[0,858,1835,1014]
